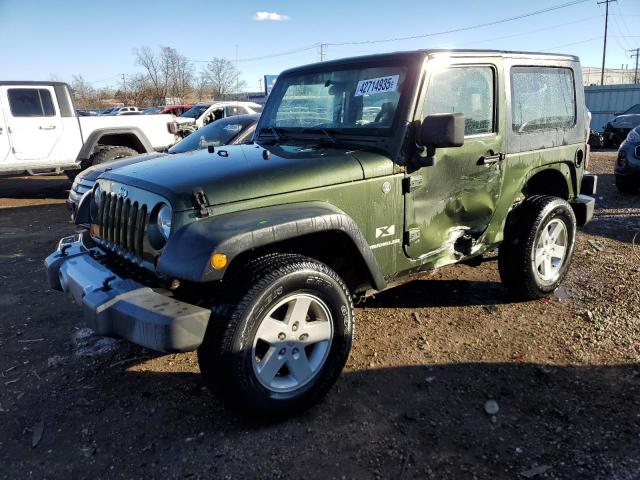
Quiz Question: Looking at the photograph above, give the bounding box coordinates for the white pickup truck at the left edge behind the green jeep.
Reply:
[0,81,179,178]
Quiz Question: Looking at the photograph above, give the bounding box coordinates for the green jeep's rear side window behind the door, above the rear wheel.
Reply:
[511,67,576,133]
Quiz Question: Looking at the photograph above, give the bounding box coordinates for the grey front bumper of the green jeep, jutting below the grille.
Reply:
[44,233,210,352]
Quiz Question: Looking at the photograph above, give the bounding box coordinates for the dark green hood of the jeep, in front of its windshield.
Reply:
[101,145,364,210]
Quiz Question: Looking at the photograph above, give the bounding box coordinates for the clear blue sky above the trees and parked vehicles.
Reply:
[0,0,640,90]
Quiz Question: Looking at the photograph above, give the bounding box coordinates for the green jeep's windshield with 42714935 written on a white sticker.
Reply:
[260,66,407,135]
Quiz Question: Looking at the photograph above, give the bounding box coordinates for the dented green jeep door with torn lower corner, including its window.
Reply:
[405,58,505,264]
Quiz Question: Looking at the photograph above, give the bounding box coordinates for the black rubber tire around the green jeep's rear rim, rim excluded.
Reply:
[498,196,576,300]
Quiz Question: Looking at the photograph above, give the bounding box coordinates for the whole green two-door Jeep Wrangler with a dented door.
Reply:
[45,50,596,417]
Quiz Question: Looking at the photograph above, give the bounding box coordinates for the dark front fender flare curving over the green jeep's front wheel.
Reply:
[157,202,386,290]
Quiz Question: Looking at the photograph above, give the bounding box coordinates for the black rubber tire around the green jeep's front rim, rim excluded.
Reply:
[198,254,354,420]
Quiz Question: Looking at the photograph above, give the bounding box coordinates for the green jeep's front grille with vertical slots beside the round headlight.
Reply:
[96,192,147,259]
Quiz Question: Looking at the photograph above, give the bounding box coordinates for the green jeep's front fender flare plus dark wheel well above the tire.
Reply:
[157,202,386,290]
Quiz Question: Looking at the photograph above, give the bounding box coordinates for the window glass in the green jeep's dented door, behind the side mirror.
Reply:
[422,66,495,135]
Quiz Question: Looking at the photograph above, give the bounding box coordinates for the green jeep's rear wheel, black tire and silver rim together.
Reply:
[498,196,576,300]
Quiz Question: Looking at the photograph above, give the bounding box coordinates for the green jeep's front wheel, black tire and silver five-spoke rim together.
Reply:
[198,254,354,418]
